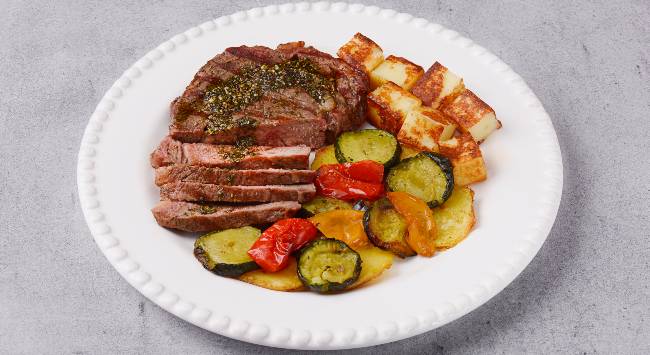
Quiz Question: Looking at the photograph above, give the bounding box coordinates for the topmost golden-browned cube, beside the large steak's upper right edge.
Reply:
[336,33,384,73]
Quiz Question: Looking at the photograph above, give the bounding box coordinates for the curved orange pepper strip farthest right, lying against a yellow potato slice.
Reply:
[386,192,437,256]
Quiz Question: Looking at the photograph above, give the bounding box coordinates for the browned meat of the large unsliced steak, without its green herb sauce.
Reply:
[170,42,369,148]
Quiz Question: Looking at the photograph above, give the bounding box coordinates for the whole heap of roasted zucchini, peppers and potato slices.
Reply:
[195,130,474,293]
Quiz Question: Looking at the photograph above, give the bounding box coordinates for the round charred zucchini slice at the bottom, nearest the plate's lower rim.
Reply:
[298,238,361,293]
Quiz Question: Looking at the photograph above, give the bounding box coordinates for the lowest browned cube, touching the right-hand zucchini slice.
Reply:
[439,133,487,186]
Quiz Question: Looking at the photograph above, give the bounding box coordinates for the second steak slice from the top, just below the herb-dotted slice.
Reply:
[155,164,316,186]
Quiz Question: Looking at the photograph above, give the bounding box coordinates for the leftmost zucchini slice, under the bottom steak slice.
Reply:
[194,227,260,277]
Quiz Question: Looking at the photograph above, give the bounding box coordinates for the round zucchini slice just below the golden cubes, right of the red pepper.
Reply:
[386,152,454,208]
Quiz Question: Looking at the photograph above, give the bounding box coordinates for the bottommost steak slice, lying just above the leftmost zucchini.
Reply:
[151,201,300,232]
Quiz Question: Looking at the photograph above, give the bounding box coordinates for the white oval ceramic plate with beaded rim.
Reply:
[78,3,562,349]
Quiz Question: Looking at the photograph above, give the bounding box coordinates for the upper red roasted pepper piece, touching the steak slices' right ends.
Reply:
[315,160,384,201]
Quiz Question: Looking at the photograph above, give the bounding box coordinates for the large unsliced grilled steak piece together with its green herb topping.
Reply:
[170,42,369,148]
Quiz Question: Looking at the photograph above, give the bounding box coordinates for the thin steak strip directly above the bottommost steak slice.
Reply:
[160,182,316,203]
